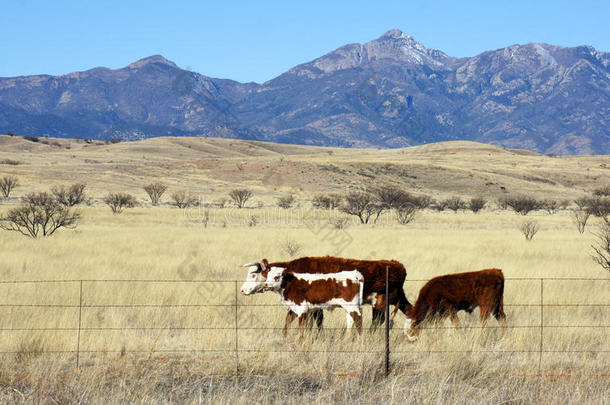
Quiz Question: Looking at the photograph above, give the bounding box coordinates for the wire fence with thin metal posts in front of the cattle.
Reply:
[0,278,610,376]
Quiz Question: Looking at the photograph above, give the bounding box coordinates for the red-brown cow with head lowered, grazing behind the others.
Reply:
[405,269,506,341]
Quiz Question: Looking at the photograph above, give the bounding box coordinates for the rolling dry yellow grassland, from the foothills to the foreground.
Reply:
[0,133,610,404]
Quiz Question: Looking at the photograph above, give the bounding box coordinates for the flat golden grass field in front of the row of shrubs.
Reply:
[0,207,610,403]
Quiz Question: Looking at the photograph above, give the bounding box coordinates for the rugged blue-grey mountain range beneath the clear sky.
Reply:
[0,29,610,154]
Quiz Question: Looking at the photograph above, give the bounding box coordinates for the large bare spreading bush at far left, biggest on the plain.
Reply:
[0,192,81,238]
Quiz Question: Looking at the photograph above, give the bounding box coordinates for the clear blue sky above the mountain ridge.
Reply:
[0,0,610,82]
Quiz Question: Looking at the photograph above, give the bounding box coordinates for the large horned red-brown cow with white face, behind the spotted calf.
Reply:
[241,256,411,334]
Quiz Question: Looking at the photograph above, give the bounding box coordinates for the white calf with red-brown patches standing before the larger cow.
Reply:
[264,267,364,339]
